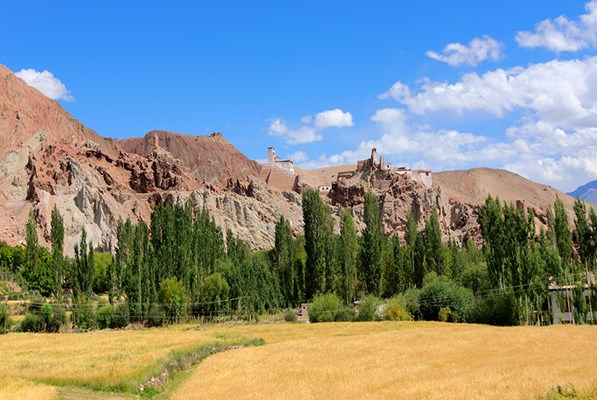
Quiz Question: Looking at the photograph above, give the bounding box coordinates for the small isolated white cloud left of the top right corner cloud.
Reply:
[425,35,502,67]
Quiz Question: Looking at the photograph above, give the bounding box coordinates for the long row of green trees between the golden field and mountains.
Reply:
[0,190,597,323]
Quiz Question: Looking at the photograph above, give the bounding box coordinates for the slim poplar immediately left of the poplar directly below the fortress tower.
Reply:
[337,209,359,304]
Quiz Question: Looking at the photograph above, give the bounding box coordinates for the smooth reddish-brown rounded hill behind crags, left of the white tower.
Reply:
[120,131,261,185]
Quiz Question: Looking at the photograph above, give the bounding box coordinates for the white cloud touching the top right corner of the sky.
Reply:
[516,0,597,53]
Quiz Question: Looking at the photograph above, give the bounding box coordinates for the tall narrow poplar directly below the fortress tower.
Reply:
[360,191,385,296]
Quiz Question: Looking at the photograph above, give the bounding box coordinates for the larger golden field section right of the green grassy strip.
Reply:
[173,323,597,399]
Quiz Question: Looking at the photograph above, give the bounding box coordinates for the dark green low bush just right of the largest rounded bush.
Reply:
[469,292,518,326]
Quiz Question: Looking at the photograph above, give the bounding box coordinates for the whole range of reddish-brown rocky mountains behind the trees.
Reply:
[0,66,572,253]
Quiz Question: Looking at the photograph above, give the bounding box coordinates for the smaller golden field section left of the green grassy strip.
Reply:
[0,327,260,398]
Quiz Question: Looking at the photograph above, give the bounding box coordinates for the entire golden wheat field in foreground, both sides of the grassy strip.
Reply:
[0,322,597,399]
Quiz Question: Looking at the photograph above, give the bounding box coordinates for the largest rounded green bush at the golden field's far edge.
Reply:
[419,276,475,322]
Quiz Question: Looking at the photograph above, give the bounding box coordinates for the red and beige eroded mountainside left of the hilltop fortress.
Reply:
[0,66,301,254]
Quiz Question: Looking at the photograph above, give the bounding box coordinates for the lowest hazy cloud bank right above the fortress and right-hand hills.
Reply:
[312,108,597,191]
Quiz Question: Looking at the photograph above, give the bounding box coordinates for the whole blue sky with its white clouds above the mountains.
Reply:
[0,0,597,191]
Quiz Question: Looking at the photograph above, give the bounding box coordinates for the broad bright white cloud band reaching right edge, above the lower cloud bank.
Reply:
[386,57,597,129]
